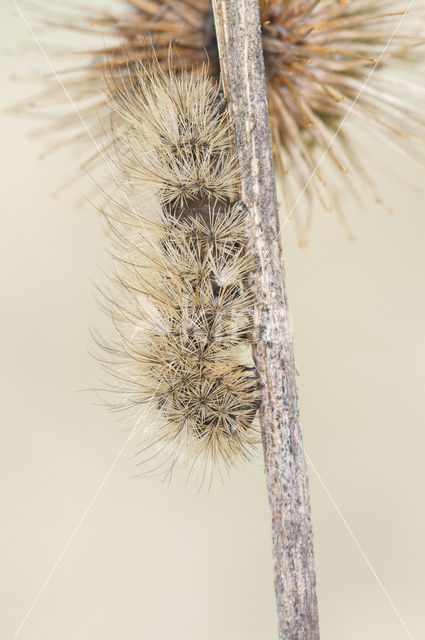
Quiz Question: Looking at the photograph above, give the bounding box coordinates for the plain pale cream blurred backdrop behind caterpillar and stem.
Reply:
[0,0,425,640]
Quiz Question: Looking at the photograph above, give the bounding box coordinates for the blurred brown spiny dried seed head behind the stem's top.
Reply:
[27,0,425,241]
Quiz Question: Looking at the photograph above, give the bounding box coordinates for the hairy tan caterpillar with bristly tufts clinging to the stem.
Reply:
[98,62,259,475]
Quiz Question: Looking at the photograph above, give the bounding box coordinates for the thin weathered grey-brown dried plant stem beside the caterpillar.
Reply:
[213,0,319,640]
